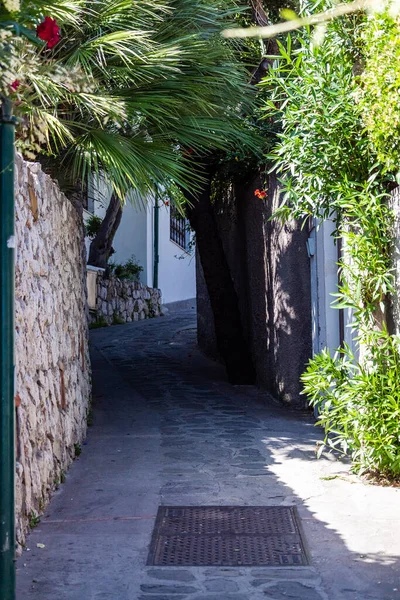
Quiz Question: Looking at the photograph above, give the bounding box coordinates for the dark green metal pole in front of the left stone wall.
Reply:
[0,99,15,600]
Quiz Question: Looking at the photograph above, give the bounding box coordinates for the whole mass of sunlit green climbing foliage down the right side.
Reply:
[262,4,400,476]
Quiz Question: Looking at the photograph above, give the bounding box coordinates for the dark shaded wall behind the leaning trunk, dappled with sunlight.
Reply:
[197,175,312,408]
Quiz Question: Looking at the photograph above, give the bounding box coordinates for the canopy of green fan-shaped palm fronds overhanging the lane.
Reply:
[2,0,257,197]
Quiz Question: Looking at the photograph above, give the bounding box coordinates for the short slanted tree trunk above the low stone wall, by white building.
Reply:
[88,194,122,269]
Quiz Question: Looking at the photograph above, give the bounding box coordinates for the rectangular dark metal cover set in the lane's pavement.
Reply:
[147,506,309,567]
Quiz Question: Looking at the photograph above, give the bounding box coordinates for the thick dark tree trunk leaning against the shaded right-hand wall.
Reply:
[185,176,255,385]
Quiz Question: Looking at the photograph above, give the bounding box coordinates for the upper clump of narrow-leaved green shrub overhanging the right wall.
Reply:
[262,7,378,219]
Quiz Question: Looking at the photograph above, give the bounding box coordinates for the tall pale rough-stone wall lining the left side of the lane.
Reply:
[15,156,90,545]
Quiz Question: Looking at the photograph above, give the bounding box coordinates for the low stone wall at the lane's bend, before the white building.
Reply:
[89,272,161,327]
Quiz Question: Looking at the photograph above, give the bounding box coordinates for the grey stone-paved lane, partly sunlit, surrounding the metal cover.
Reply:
[18,311,400,600]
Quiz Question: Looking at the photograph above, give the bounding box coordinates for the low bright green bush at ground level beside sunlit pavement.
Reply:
[302,331,400,476]
